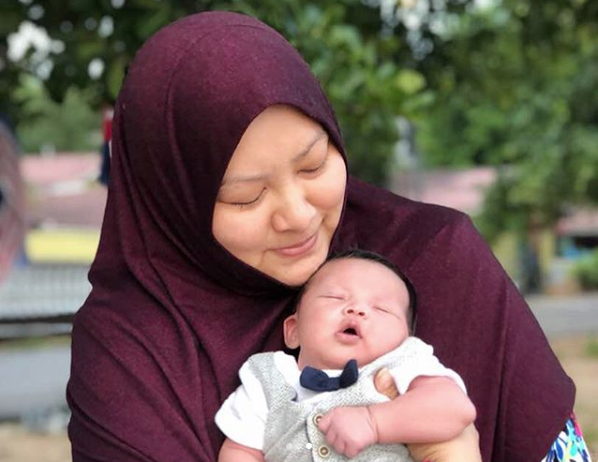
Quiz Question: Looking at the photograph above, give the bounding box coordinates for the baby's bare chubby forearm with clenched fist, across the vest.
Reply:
[318,376,476,457]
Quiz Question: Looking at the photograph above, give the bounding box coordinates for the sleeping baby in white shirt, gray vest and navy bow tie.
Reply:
[216,250,475,462]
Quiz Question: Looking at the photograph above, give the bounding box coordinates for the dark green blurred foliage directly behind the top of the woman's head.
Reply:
[0,0,464,184]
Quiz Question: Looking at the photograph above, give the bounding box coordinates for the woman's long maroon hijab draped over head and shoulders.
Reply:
[67,12,574,462]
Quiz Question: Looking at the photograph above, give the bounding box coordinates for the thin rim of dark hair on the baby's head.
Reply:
[294,249,417,334]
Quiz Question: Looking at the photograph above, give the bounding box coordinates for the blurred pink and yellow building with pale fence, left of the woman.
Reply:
[0,153,107,338]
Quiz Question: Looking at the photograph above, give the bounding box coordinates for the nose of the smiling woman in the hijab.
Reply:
[272,187,316,231]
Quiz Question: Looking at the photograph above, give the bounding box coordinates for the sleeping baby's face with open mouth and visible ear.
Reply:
[284,258,409,369]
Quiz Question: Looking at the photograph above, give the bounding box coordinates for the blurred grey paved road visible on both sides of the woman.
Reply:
[0,294,598,420]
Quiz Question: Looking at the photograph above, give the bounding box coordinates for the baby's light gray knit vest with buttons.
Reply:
[248,337,423,462]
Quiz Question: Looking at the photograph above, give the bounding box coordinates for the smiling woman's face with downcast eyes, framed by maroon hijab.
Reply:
[212,106,347,286]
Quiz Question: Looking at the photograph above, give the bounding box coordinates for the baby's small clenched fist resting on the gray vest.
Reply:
[318,406,378,459]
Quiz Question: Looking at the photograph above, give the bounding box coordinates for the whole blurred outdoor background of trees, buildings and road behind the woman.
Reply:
[0,0,598,462]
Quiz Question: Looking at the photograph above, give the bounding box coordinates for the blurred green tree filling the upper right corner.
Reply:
[418,0,598,242]
